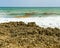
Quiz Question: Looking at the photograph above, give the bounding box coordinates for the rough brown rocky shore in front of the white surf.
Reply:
[0,22,60,48]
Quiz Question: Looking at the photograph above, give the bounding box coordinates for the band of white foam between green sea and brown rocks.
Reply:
[0,16,60,28]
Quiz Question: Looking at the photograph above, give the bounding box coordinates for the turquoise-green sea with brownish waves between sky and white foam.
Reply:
[0,7,60,18]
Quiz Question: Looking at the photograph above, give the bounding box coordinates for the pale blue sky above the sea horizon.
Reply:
[0,0,60,7]
